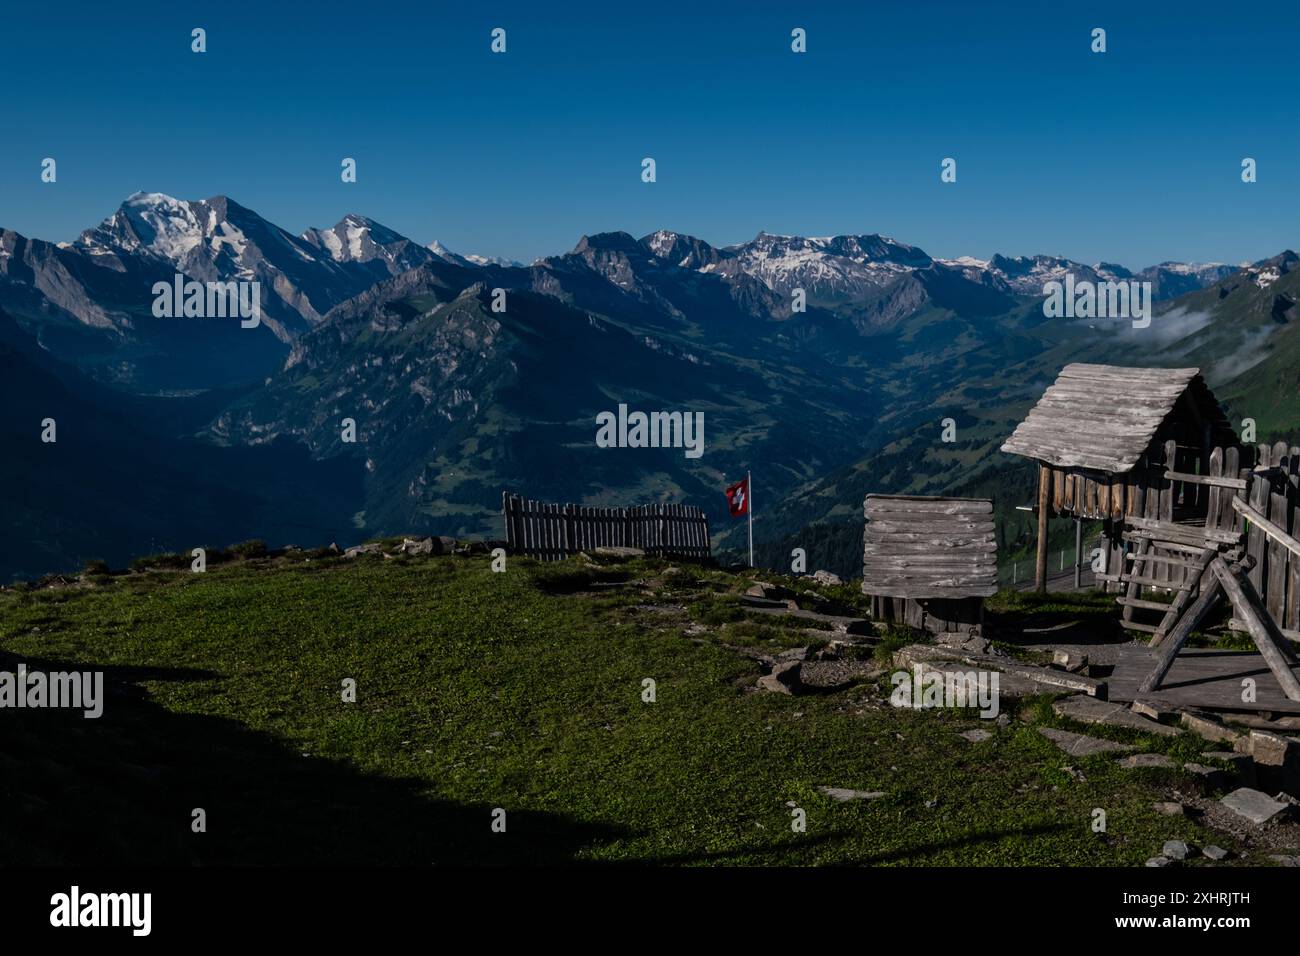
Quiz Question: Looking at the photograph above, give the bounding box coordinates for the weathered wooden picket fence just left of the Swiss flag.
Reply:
[501,492,712,561]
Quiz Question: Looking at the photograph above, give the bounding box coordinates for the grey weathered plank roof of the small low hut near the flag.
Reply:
[862,494,997,598]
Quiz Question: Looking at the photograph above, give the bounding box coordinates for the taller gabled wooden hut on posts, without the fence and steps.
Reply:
[1002,364,1240,591]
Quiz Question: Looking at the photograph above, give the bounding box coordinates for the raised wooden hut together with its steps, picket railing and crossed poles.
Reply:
[1002,364,1300,702]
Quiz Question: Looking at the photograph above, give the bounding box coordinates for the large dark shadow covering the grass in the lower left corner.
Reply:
[0,654,627,866]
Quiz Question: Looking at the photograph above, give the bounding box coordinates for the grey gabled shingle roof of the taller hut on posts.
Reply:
[1002,364,1231,475]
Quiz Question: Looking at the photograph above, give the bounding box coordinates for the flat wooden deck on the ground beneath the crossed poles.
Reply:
[1106,644,1300,714]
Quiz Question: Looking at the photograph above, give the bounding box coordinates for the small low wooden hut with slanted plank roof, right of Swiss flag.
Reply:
[862,494,997,632]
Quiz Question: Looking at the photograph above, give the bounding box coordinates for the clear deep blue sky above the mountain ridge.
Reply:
[0,0,1300,267]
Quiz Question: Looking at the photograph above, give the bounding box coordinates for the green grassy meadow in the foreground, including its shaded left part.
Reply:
[0,553,1237,865]
